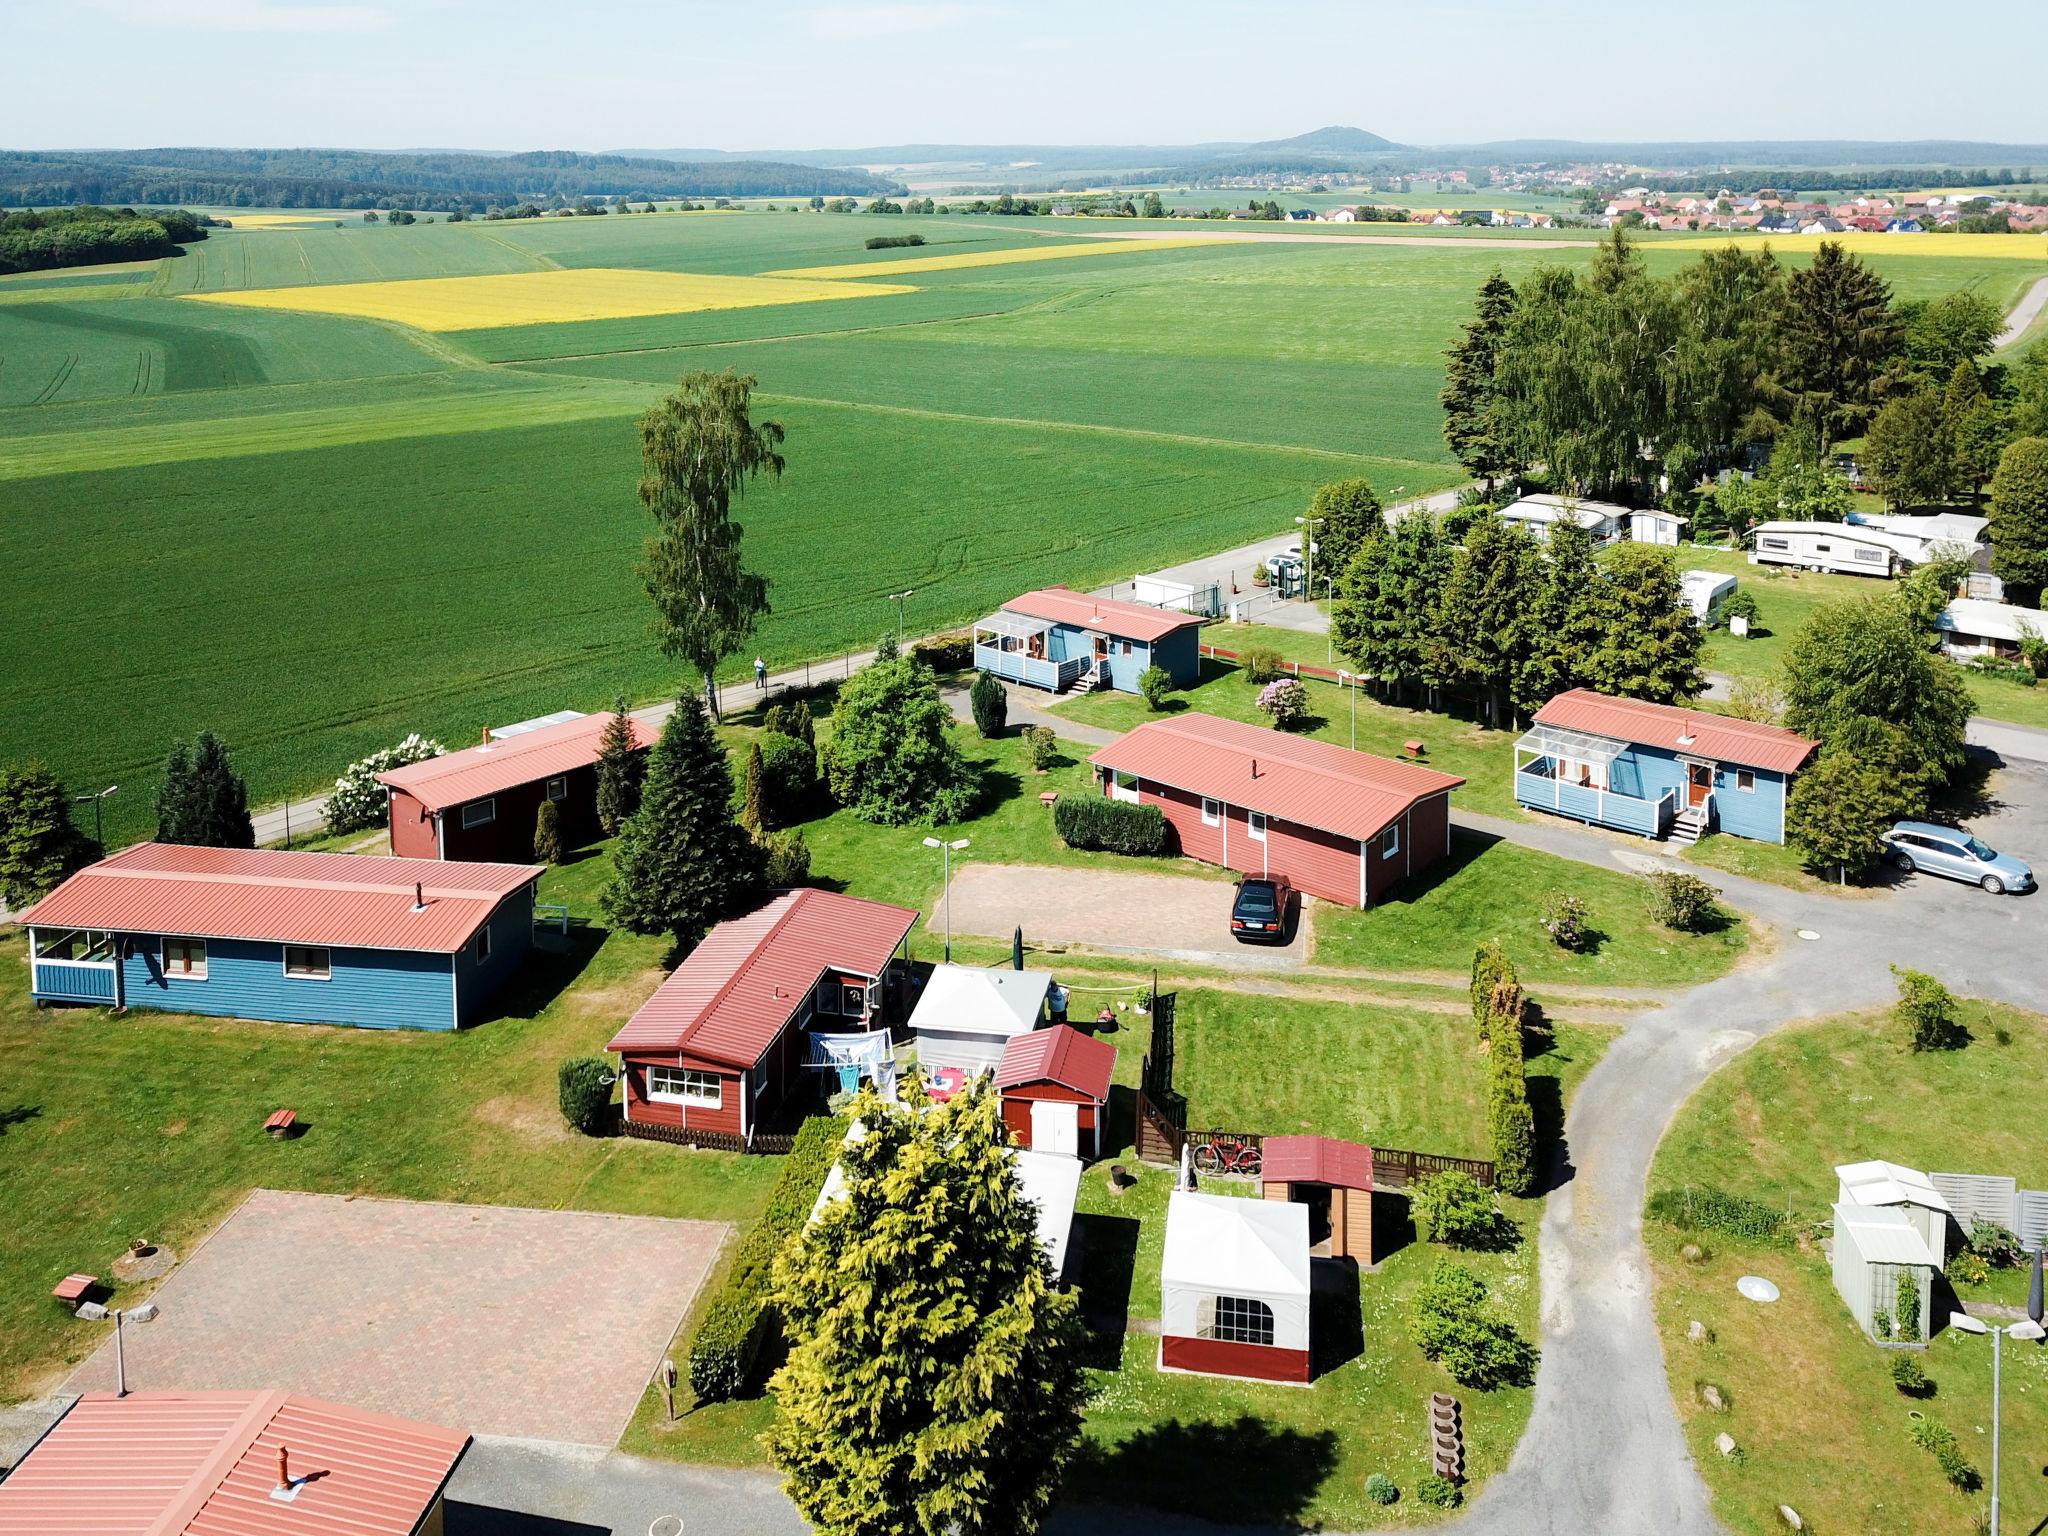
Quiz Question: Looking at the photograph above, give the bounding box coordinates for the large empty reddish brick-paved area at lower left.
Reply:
[66,1190,731,1446]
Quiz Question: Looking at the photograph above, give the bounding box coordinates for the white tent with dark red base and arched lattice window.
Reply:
[1159,1190,1309,1380]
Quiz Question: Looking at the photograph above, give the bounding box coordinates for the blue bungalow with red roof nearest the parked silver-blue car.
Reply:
[1516,688,1817,842]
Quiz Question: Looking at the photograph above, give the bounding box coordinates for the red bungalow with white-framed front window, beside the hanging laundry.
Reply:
[604,889,918,1147]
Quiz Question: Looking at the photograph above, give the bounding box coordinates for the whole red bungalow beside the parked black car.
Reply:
[1090,713,1464,907]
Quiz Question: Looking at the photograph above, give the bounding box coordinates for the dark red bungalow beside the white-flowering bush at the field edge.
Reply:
[377,711,655,862]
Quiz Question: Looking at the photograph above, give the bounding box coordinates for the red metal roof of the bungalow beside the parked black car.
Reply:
[1090,715,1464,842]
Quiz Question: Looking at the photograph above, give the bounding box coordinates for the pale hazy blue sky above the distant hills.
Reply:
[0,0,2048,150]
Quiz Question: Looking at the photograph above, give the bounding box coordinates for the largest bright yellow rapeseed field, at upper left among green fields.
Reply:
[182,266,915,330]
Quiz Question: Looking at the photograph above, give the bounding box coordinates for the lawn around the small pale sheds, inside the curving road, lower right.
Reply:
[1647,1004,2048,1536]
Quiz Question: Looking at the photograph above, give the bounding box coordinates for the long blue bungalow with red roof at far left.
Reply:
[16,842,543,1030]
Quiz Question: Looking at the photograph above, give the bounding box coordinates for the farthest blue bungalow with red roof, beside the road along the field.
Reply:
[975,586,1202,694]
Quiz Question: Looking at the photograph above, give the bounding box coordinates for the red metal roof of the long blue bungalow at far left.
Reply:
[18,842,545,954]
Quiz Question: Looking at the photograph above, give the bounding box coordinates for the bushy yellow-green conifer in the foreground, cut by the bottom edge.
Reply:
[764,1077,1087,1536]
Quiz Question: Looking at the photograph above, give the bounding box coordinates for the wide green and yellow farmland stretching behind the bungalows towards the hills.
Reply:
[0,211,2036,838]
